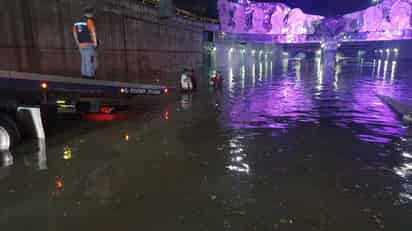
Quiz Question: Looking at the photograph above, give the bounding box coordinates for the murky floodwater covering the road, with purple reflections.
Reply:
[0,48,412,231]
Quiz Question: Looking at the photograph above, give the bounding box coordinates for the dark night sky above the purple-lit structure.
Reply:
[174,0,371,18]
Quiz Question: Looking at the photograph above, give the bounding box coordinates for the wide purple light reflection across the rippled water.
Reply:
[225,51,406,143]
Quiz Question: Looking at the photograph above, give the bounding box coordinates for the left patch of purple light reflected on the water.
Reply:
[226,75,317,129]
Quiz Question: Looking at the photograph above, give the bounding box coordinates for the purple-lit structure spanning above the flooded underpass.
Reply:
[218,0,412,43]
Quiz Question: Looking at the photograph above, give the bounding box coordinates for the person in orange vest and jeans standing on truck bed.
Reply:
[73,8,97,78]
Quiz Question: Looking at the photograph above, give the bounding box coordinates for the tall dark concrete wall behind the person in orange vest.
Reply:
[0,0,205,83]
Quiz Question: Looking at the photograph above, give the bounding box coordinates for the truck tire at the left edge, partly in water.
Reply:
[0,114,21,151]
